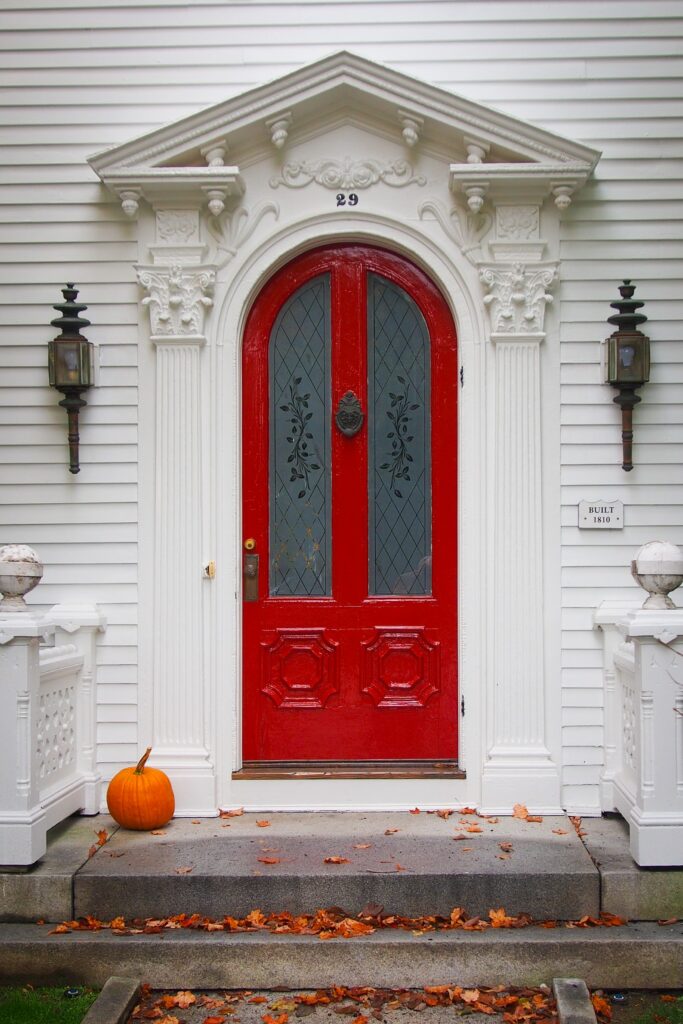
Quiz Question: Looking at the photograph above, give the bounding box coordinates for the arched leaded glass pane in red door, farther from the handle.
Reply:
[368,274,431,595]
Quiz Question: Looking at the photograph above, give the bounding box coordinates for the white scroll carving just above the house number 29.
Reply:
[270,157,427,189]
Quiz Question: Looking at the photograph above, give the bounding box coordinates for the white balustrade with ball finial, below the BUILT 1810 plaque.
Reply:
[595,542,683,867]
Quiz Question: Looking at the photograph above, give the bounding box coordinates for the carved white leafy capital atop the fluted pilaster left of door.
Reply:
[137,263,216,338]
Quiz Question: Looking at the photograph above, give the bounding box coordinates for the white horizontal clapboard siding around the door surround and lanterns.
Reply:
[0,0,683,798]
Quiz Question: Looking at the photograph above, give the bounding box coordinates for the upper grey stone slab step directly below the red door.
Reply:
[74,812,600,920]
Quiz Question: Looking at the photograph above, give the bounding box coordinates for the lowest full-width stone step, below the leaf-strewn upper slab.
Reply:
[0,924,683,989]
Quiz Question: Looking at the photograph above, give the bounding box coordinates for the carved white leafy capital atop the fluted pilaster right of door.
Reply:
[479,263,557,335]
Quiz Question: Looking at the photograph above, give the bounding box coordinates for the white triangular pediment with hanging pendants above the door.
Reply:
[89,51,600,215]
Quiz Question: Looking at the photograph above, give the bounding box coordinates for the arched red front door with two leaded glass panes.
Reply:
[243,245,458,762]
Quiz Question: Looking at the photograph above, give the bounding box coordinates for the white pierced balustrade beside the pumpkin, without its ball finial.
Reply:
[0,577,104,866]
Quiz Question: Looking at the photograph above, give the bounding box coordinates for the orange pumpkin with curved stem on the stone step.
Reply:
[106,746,175,831]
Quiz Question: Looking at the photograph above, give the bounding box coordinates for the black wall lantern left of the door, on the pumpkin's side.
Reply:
[48,284,94,473]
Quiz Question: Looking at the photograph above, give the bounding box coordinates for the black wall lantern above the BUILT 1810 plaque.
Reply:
[607,281,650,473]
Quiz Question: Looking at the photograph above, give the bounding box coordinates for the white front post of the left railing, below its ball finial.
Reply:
[0,612,51,865]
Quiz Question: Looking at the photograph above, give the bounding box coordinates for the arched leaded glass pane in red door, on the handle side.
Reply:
[269,275,332,597]
